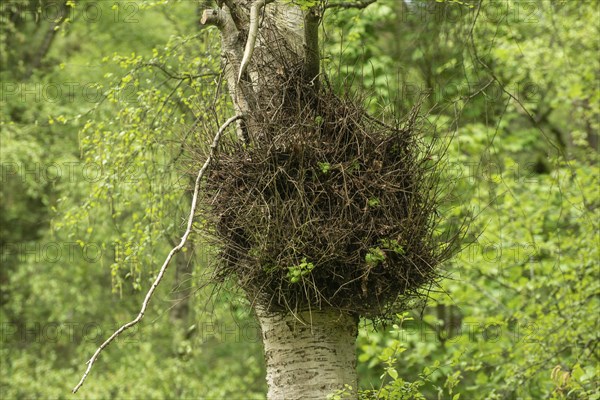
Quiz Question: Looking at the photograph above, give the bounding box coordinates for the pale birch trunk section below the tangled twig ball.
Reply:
[255,307,358,400]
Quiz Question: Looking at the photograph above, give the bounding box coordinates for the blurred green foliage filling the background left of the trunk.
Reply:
[0,0,266,399]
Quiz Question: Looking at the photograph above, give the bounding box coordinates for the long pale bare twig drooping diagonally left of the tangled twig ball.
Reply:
[73,115,242,393]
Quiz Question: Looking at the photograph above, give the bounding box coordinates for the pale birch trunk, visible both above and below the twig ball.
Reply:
[201,0,358,400]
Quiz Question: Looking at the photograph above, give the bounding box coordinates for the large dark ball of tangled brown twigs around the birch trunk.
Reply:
[202,72,460,316]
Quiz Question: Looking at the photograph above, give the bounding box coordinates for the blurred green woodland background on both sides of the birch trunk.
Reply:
[0,0,600,399]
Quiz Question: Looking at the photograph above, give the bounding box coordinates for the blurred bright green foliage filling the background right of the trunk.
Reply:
[326,1,600,399]
